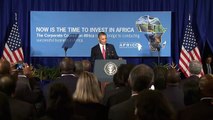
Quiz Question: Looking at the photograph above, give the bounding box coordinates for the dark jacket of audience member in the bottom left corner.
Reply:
[9,98,35,120]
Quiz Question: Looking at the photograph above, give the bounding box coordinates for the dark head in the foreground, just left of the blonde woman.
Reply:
[47,83,73,120]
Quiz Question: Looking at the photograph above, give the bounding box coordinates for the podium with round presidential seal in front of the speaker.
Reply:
[94,59,126,82]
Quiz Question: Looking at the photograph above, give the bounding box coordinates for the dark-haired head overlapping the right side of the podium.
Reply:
[113,64,135,87]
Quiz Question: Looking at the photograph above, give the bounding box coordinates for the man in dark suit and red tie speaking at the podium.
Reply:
[91,32,118,65]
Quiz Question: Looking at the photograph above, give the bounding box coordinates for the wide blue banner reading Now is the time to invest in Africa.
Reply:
[30,11,171,57]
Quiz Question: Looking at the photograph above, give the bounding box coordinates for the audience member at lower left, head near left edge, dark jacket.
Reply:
[0,75,36,120]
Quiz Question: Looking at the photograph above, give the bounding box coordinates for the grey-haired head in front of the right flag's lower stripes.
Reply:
[189,60,202,75]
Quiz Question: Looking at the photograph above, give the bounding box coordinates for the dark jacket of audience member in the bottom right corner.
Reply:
[178,100,213,120]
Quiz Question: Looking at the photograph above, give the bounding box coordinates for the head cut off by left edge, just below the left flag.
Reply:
[0,59,10,75]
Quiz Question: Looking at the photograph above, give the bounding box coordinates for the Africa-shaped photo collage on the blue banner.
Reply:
[136,15,166,51]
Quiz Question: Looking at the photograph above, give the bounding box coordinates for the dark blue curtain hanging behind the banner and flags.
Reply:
[0,0,213,66]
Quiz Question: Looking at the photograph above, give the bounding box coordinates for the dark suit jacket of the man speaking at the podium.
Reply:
[91,43,118,65]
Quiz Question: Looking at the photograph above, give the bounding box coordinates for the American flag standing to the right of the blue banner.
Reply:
[179,17,203,77]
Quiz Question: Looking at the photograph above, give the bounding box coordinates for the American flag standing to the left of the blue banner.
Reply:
[3,21,24,63]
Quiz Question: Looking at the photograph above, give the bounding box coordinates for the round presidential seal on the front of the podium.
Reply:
[104,62,118,76]
